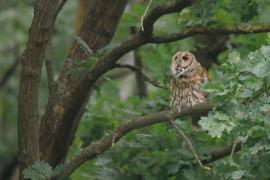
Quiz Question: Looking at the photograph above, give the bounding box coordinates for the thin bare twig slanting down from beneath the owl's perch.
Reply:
[169,118,210,170]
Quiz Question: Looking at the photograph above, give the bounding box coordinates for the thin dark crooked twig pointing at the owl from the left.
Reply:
[114,63,169,90]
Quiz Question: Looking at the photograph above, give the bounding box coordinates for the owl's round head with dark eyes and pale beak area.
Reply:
[171,51,198,78]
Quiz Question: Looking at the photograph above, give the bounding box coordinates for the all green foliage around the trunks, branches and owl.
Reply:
[0,0,270,180]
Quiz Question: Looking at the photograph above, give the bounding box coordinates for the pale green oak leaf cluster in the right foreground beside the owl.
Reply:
[199,46,270,179]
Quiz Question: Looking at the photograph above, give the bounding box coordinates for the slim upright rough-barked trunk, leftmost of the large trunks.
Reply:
[18,0,62,179]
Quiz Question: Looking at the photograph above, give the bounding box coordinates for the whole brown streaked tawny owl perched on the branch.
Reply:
[170,51,208,112]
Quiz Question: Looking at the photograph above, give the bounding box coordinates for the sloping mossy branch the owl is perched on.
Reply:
[59,103,211,179]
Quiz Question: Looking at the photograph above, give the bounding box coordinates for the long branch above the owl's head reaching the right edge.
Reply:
[148,24,270,44]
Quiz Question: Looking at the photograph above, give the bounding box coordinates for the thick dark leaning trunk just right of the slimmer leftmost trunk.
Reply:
[40,0,127,165]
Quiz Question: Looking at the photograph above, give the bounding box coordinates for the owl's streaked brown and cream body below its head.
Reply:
[170,69,208,112]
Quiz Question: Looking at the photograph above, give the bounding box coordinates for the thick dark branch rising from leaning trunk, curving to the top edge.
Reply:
[93,0,193,73]
